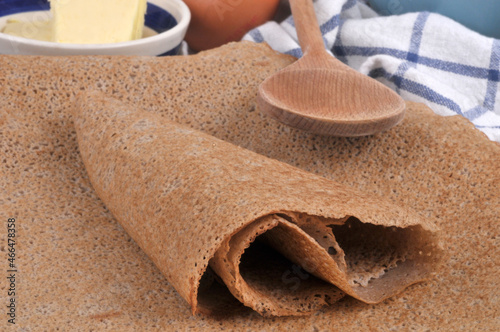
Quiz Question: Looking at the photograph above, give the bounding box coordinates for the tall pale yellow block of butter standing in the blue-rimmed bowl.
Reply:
[50,0,146,44]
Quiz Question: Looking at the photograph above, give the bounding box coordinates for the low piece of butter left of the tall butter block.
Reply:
[2,19,52,41]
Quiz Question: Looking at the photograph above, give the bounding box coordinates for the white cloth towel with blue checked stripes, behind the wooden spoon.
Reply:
[243,0,500,142]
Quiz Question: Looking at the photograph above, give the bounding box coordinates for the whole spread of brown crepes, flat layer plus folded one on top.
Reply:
[0,42,500,331]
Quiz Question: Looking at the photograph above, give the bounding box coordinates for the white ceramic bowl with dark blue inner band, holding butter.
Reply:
[0,0,191,56]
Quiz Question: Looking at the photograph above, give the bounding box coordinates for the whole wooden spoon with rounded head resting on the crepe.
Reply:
[257,0,405,136]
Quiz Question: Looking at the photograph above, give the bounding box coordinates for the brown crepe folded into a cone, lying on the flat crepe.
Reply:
[73,92,440,316]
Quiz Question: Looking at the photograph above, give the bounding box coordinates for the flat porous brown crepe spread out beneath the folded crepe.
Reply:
[0,43,500,331]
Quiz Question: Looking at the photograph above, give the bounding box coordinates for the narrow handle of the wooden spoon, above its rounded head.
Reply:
[290,0,326,55]
